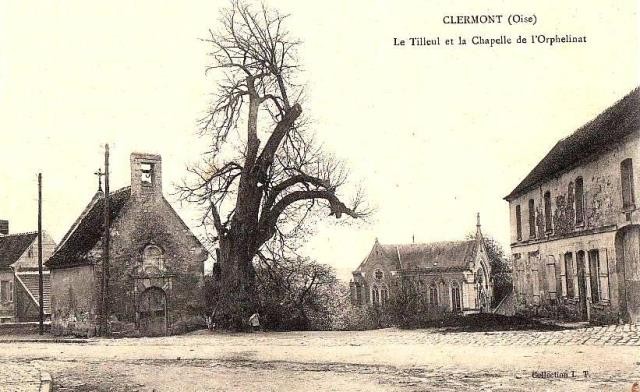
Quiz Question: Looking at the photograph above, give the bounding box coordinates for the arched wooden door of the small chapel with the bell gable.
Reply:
[138,286,167,336]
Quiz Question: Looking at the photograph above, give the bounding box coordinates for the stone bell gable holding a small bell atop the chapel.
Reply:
[130,152,162,199]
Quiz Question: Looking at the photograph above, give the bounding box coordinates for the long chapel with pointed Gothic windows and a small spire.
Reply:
[350,216,493,313]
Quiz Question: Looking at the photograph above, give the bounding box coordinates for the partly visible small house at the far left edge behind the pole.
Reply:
[0,221,56,323]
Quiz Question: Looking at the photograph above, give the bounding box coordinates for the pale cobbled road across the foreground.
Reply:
[0,325,640,391]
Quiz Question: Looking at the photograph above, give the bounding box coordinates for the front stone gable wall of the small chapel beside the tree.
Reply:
[105,197,206,325]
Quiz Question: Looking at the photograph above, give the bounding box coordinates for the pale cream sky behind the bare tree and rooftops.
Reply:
[0,0,640,279]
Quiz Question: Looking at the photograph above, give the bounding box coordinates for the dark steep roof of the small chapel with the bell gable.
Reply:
[45,187,131,268]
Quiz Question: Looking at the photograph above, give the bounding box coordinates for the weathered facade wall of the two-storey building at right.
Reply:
[509,135,640,323]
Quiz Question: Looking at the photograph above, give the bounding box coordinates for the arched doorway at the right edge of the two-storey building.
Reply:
[616,225,640,324]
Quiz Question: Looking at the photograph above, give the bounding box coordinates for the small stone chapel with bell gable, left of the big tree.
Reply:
[47,153,207,335]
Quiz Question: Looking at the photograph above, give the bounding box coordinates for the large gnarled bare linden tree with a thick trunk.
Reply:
[179,1,367,327]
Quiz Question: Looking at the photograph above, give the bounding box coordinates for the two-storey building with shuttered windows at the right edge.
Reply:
[505,89,640,323]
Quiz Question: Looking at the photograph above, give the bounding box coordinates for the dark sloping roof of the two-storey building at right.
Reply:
[505,88,640,201]
